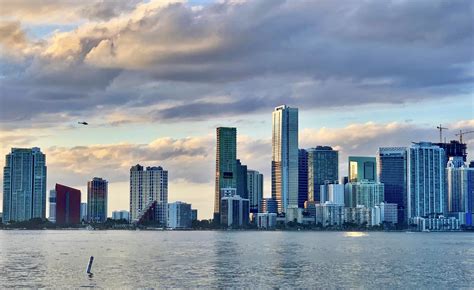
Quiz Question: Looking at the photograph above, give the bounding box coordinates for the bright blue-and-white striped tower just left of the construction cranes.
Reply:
[407,142,447,218]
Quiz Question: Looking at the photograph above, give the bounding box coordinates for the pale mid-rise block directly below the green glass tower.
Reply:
[344,180,384,207]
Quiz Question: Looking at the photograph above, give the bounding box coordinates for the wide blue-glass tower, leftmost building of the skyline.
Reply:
[3,147,46,223]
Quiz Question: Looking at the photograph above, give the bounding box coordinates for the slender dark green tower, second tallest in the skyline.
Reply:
[214,127,237,221]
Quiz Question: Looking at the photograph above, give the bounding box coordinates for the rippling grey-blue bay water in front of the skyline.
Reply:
[0,230,474,288]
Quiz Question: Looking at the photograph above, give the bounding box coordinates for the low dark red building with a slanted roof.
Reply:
[56,183,81,224]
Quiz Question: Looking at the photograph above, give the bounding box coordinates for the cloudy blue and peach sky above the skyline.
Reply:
[0,0,474,219]
